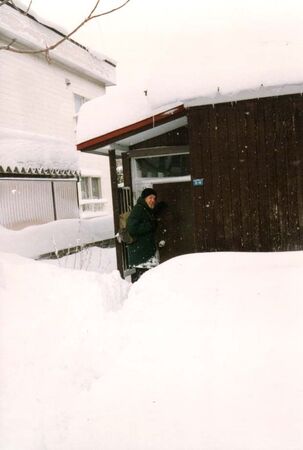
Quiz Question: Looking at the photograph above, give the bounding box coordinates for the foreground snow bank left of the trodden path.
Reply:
[0,253,128,450]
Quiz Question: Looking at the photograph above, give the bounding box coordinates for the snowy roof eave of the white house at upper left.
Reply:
[0,2,116,86]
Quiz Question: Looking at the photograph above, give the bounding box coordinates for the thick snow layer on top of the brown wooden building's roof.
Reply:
[77,9,303,143]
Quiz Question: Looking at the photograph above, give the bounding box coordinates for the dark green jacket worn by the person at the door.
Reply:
[126,197,157,266]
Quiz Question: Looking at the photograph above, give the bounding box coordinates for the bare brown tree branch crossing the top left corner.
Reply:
[0,0,130,57]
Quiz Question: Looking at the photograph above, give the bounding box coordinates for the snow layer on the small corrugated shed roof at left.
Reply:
[0,128,79,175]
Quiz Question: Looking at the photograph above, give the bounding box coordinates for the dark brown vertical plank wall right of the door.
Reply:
[188,95,303,251]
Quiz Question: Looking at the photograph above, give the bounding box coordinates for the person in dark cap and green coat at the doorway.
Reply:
[126,188,157,280]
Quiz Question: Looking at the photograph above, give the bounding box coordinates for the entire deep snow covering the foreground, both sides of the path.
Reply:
[0,246,303,450]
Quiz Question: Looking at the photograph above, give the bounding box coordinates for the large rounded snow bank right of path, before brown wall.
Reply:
[95,252,303,450]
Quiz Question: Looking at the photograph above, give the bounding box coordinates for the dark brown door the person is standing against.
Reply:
[153,182,194,262]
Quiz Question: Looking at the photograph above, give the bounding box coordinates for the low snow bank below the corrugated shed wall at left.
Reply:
[0,215,115,258]
